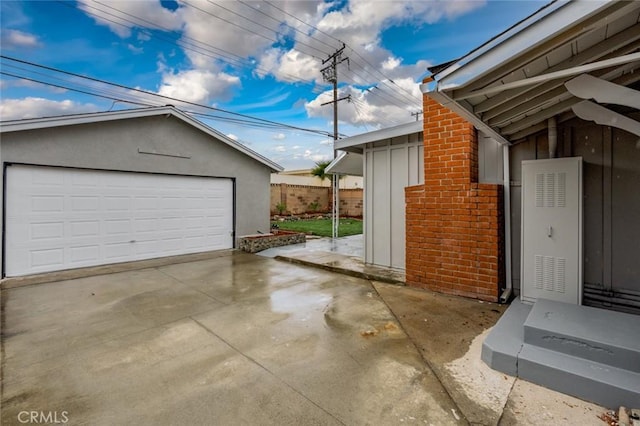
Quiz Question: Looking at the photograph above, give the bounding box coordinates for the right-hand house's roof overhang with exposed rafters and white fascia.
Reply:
[420,0,640,144]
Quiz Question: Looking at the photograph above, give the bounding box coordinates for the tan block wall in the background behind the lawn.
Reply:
[271,183,362,216]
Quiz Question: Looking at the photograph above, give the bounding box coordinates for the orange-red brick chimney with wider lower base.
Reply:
[405,95,504,301]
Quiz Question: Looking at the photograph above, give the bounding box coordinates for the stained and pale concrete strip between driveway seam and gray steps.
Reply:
[373,282,615,426]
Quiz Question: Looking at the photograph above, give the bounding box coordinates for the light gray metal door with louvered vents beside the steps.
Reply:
[521,157,582,304]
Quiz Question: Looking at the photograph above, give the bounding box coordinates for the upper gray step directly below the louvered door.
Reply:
[524,299,640,372]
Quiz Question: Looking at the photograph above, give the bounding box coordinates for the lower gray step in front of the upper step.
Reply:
[518,342,640,408]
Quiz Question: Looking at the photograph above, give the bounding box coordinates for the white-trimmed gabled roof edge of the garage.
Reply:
[0,106,283,172]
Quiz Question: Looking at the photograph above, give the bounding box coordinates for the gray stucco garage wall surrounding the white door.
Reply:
[0,115,271,270]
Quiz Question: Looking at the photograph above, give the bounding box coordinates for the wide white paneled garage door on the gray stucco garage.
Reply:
[5,165,233,276]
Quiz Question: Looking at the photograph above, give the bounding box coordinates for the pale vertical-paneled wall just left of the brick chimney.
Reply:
[363,133,424,269]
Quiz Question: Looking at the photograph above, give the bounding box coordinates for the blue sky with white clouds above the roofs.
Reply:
[0,0,546,169]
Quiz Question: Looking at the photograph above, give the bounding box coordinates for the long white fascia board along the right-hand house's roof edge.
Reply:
[420,0,611,93]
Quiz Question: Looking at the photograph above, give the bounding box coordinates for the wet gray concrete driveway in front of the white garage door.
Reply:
[1,251,466,425]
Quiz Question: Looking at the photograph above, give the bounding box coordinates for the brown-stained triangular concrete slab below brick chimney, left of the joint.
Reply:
[374,282,513,425]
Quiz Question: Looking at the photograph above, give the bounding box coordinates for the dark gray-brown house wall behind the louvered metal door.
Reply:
[509,113,640,312]
